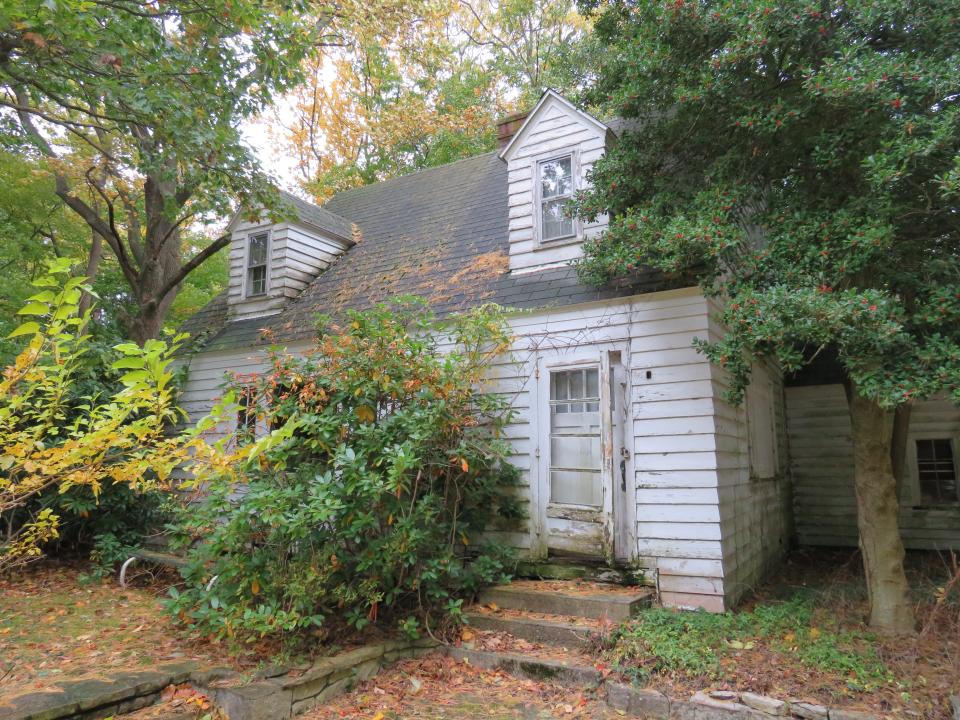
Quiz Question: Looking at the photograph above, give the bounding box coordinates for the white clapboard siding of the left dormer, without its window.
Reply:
[228,219,347,320]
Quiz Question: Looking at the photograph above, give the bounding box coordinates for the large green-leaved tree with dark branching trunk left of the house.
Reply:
[0,0,322,340]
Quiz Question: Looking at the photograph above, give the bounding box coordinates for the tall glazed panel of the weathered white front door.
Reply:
[550,367,603,507]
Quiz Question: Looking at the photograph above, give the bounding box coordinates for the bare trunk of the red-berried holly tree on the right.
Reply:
[848,384,915,635]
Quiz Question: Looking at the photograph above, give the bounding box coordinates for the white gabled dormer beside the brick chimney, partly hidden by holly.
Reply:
[498,90,614,274]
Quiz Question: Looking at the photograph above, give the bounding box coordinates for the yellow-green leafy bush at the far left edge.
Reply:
[0,259,185,571]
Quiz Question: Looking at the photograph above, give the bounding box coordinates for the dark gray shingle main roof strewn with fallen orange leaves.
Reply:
[184,152,677,350]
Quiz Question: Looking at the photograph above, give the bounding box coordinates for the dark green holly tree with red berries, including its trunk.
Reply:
[577,0,960,630]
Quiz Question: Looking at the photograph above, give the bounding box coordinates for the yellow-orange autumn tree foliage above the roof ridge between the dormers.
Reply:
[275,0,590,199]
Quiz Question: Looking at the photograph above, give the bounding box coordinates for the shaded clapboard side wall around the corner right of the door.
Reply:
[707,300,793,607]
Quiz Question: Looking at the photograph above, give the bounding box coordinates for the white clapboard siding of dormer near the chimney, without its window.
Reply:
[504,93,607,272]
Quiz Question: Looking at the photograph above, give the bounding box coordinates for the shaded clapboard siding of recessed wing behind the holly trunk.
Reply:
[786,385,960,549]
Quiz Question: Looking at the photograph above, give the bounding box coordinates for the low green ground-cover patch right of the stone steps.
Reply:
[609,591,894,691]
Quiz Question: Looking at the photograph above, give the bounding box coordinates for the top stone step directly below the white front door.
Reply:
[480,580,653,623]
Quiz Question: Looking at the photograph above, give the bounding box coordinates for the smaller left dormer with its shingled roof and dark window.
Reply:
[227,193,354,320]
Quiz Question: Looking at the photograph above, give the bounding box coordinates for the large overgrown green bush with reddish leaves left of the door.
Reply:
[169,301,519,641]
